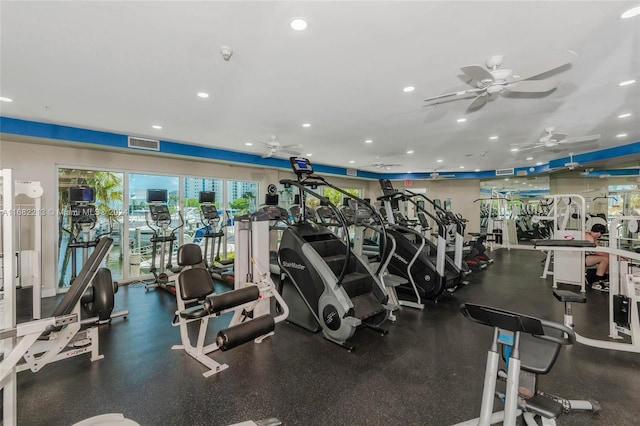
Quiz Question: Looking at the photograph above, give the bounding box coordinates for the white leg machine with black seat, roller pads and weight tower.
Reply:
[172,213,289,377]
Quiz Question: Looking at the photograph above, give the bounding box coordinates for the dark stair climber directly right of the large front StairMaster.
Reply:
[378,179,464,304]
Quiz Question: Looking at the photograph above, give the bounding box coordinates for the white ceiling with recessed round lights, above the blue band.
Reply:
[0,1,640,172]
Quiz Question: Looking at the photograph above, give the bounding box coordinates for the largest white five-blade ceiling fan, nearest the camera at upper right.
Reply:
[424,50,578,111]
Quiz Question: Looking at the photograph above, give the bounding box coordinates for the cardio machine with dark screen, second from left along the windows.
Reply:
[144,189,184,294]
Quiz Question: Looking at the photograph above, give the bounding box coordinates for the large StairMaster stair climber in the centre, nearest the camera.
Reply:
[278,157,390,351]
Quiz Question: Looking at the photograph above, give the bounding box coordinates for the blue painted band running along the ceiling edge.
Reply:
[0,116,640,180]
